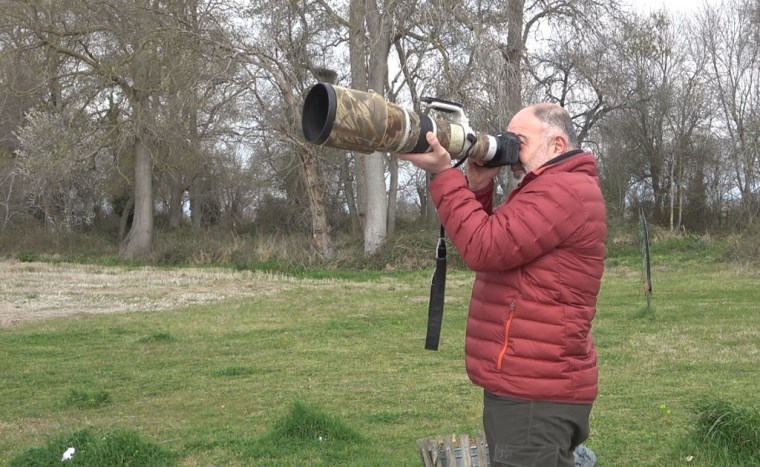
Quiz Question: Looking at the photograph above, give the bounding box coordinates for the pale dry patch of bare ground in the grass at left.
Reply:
[0,260,296,327]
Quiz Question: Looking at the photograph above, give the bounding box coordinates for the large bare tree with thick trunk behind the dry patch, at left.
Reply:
[5,2,166,257]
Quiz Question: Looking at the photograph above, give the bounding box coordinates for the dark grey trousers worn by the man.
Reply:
[483,391,591,467]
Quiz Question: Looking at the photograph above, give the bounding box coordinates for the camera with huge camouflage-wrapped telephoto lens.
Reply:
[301,83,520,167]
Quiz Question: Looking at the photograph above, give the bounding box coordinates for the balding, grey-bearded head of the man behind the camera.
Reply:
[507,103,578,171]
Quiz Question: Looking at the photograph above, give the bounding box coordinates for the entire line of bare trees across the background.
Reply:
[0,0,760,258]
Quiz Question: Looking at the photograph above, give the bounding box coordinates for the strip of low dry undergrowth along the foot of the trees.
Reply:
[0,218,760,274]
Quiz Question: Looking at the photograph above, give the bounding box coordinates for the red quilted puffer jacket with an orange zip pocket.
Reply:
[430,151,607,404]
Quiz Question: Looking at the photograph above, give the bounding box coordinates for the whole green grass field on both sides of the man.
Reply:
[0,256,760,467]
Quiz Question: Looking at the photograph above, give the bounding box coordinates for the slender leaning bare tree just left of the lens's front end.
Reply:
[239,2,334,258]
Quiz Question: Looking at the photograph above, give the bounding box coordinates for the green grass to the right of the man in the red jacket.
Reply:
[588,263,760,466]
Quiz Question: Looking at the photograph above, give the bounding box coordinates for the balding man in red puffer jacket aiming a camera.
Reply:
[395,103,607,467]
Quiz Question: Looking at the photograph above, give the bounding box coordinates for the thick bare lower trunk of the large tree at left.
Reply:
[121,135,153,259]
